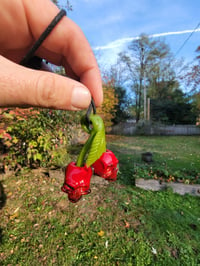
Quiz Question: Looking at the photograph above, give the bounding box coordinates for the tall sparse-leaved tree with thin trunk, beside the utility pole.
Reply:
[119,34,169,122]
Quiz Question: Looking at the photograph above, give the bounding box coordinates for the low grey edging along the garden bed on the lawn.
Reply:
[135,178,200,197]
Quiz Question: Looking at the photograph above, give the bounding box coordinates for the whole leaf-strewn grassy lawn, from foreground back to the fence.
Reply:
[0,136,200,266]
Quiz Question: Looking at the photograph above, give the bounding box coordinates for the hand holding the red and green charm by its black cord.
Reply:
[0,0,103,110]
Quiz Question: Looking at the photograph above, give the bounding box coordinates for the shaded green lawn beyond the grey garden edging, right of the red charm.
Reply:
[109,136,200,184]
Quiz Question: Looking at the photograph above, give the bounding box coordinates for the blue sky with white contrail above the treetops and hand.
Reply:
[60,0,200,67]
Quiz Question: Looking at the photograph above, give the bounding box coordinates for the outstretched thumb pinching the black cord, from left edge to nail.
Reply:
[0,56,91,110]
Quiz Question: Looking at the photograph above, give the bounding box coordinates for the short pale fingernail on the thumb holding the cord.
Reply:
[71,87,91,109]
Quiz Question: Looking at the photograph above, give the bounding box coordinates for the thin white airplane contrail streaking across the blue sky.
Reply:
[93,28,200,51]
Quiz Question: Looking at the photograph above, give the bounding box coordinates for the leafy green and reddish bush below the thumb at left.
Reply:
[0,108,80,168]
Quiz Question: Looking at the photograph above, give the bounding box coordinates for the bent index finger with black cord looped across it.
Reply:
[24,0,103,106]
